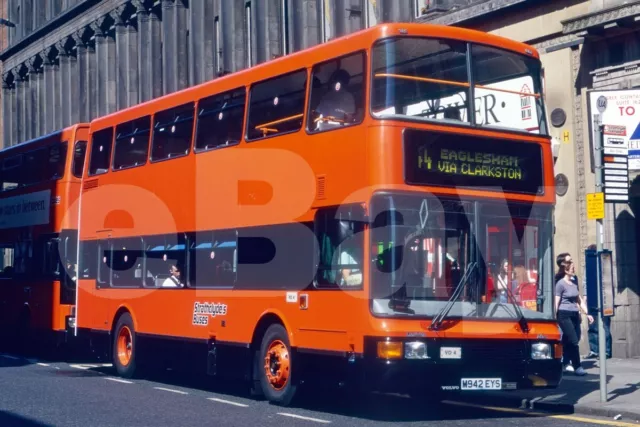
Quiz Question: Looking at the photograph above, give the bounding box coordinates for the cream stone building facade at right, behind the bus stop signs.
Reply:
[419,0,640,358]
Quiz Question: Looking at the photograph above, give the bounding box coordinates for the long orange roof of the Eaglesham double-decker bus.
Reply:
[91,23,539,130]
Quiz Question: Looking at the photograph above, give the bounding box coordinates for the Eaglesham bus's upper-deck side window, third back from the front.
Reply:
[195,88,246,151]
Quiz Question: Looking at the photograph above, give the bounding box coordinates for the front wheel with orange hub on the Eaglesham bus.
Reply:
[259,324,297,406]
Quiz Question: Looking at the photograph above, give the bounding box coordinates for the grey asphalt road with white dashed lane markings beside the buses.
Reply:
[0,353,637,427]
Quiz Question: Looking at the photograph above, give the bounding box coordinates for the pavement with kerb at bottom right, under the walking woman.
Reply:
[460,359,640,423]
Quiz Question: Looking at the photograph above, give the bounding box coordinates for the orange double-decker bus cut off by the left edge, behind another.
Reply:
[0,124,89,347]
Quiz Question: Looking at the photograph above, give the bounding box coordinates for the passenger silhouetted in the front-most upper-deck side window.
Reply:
[316,69,356,130]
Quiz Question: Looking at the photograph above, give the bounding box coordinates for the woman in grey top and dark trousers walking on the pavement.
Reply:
[555,253,593,375]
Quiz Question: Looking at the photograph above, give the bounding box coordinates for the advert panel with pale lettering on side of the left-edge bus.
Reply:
[0,190,51,229]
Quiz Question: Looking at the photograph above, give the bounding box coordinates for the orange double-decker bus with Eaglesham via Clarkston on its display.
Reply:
[77,24,562,404]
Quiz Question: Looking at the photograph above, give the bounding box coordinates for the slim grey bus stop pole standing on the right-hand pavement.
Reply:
[595,125,607,403]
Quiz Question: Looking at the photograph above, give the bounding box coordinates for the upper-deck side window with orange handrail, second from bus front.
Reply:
[247,70,307,140]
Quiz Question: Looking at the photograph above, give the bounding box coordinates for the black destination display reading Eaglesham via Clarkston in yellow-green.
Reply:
[404,129,544,194]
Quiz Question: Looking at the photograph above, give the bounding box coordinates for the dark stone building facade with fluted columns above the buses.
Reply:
[0,0,436,149]
